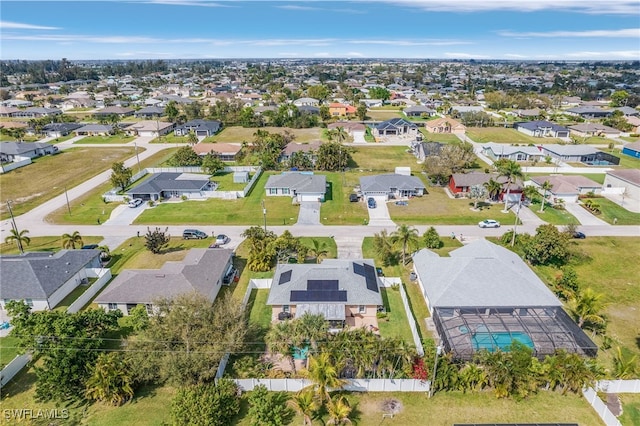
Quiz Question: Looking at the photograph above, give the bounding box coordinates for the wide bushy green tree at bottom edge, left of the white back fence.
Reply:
[171,379,240,426]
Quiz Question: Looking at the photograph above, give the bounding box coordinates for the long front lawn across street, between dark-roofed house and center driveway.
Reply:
[134,173,300,226]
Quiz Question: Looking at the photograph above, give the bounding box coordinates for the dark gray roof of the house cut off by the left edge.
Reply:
[0,250,100,300]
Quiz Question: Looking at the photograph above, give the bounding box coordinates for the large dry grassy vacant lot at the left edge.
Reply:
[0,147,139,220]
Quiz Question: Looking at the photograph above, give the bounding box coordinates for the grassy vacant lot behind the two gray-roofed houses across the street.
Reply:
[349,145,422,173]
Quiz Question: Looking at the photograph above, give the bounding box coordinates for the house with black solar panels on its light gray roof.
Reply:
[267,259,383,328]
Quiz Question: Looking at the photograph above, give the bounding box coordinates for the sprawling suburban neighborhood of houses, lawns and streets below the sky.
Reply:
[0,28,640,425]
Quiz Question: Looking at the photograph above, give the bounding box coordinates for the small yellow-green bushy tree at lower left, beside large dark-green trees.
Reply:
[86,352,133,406]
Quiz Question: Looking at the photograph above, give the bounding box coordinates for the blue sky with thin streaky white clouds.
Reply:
[0,0,640,60]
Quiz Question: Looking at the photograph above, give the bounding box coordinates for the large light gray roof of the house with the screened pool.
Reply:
[413,239,562,308]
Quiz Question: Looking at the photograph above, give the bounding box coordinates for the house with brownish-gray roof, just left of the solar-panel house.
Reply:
[95,248,235,315]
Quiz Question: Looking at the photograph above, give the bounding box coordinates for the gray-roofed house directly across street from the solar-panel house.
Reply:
[264,172,327,202]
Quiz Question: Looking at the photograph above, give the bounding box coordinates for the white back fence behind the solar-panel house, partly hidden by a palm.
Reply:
[233,379,429,392]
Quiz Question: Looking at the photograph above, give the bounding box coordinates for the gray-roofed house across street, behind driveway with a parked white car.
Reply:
[360,173,427,199]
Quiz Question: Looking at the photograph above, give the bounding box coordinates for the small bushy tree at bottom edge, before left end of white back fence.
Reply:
[248,385,292,426]
